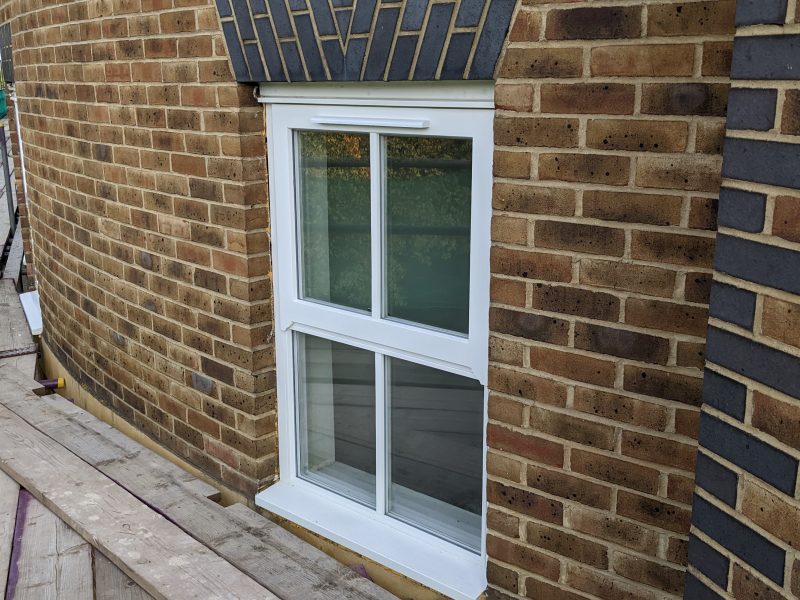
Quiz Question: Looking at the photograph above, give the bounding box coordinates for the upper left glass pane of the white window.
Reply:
[297,131,371,310]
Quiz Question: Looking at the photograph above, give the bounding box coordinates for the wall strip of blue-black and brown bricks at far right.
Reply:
[686,1,800,600]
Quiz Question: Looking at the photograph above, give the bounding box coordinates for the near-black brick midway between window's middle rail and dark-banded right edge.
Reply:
[575,323,669,365]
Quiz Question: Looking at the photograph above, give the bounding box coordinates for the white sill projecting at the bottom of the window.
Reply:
[255,479,486,600]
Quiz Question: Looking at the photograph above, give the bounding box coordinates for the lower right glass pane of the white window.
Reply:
[387,358,483,551]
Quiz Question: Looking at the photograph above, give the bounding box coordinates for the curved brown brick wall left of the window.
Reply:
[3,0,276,494]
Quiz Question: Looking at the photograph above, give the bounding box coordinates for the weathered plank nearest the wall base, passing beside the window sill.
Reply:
[0,369,395,600]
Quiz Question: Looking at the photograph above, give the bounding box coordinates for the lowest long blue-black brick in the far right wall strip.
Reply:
[692,496,786,586]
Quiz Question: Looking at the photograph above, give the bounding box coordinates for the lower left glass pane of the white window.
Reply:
[296,334,375,507]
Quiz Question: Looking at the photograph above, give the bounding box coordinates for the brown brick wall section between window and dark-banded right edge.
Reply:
[488,0,735,600]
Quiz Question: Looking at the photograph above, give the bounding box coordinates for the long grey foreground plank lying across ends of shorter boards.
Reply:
[0,398,276,600]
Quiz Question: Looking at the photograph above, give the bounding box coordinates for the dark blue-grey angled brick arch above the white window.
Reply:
[216,0,516,83]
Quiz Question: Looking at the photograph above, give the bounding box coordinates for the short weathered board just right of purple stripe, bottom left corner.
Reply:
[6,490,94,600]
